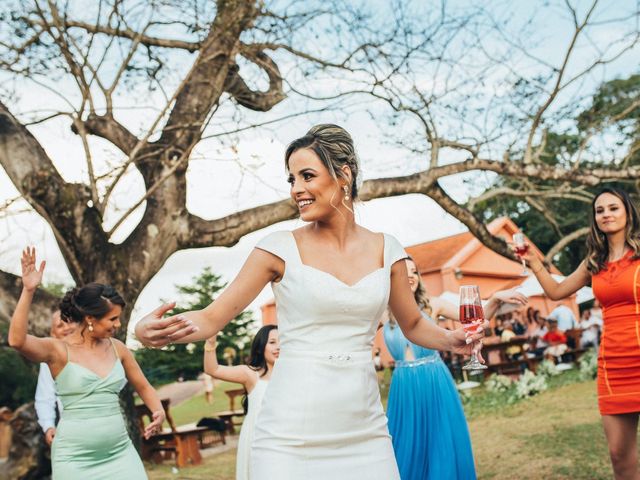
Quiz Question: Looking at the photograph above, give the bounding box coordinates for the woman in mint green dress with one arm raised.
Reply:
[9,248,164,480]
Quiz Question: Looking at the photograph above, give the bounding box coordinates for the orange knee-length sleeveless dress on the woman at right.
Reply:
[592,252,640,415]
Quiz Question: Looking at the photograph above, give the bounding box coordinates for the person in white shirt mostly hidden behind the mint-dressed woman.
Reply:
[35,310,76,446]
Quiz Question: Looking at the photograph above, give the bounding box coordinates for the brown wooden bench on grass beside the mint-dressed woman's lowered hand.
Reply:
[136,399,226,467]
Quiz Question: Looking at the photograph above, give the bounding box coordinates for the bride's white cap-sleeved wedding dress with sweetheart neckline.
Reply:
[251,232,407,480]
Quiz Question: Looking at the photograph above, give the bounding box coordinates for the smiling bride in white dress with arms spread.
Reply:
[136,125,483,480]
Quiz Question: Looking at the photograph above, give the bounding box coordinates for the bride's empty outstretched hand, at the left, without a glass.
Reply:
[135,302,199,348]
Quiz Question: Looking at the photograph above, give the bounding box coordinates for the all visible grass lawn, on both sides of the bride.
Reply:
[149,371,636,480]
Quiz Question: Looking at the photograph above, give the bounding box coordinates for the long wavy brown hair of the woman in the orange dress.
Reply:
[586,187,640,274]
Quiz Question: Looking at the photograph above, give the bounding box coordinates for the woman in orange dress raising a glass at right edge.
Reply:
[525,188,640,480]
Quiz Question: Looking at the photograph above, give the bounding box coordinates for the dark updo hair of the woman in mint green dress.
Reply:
[60,282,126,323]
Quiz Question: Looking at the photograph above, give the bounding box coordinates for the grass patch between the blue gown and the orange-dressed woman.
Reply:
[469,381,612,480]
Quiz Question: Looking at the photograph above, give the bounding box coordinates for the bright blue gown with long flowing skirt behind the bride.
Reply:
[384,315,476,480]
